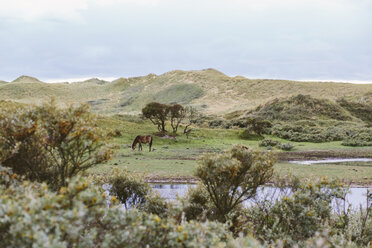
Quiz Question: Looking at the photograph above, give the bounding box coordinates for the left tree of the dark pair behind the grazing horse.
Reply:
[142,102,170,132]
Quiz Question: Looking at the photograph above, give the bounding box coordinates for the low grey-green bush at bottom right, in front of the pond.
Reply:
[245,179,345,247]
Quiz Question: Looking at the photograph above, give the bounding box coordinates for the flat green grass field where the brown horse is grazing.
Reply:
[89,116,372,185]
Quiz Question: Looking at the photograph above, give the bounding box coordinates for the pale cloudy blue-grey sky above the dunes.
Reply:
[0,0,372,83]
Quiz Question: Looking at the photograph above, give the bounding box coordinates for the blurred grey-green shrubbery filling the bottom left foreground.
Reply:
[0,166,244,248]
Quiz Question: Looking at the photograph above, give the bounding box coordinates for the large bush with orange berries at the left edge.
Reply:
[0,101,111,190]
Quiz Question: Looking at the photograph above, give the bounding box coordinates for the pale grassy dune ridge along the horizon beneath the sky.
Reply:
[0,69,372,115]
